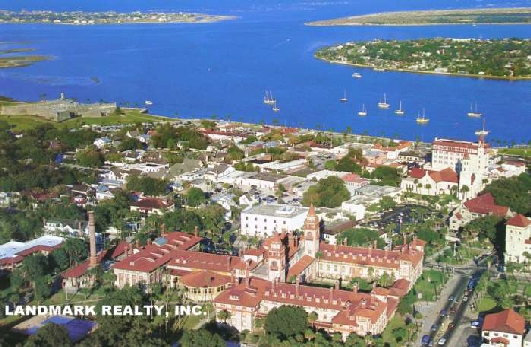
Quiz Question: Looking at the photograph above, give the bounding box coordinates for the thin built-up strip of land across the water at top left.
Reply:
[0,11,237,25]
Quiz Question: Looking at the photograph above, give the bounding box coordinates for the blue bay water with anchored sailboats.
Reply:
[0,0,531,142]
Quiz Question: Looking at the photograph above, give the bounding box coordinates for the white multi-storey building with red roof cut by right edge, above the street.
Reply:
[504,214,531,263]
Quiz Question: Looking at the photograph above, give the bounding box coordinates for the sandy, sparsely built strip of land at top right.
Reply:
[306,7,531,26]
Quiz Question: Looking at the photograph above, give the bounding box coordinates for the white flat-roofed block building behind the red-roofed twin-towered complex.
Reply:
[241,204,308,237]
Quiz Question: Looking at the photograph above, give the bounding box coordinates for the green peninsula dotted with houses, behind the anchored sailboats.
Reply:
[315,38,531,80]
